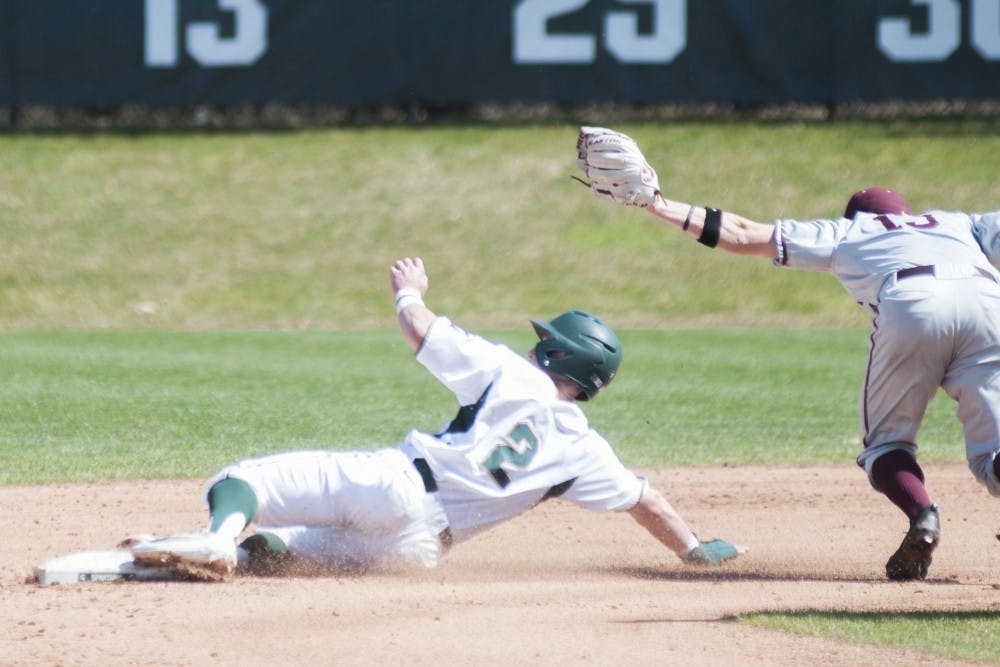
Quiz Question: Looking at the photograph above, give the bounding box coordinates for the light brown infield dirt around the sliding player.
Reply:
[0,464,1000,667]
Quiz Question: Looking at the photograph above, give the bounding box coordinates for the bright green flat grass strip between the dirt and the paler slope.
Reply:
[0,329,964,484]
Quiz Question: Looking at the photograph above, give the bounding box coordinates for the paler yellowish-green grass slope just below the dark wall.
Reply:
[0,119,1000,330]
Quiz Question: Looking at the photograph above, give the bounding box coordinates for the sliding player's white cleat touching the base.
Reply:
[132,532,236,578]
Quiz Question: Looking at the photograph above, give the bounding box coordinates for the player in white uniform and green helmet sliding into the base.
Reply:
[132,258,744,574]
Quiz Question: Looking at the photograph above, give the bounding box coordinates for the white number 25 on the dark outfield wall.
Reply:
[512,0,687,65]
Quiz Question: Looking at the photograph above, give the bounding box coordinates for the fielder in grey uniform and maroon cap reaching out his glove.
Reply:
[577,127,1000,581]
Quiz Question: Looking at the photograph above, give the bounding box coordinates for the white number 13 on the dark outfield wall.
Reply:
[145,0,267,67]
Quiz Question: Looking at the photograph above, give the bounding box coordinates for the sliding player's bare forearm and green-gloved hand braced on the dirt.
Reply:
[629,486,746,565]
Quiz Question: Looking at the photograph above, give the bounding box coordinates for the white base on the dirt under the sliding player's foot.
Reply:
[35,549,185,584]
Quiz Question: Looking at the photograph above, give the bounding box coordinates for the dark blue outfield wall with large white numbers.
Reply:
[0,0,1000,108]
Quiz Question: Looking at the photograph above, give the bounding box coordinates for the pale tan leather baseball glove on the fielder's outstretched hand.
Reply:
[576,127,660,207]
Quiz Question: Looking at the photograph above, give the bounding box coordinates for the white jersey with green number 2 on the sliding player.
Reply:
[403,317,645,540]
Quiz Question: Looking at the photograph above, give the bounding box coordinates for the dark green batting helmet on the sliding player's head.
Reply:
[531,310,622,401]
